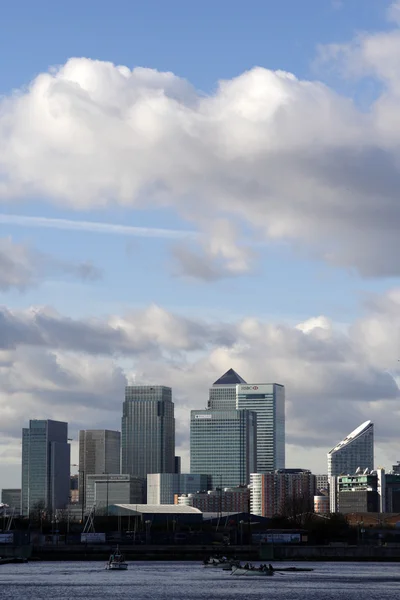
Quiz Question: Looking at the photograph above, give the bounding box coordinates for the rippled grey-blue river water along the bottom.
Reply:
[0,562,400,600]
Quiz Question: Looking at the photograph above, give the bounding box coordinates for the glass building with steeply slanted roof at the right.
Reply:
[328,421,374,512]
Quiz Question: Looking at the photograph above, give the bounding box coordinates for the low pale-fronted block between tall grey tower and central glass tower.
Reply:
[147,473,210,504]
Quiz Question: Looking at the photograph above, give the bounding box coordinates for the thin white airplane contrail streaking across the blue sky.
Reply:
[0,213,199,239]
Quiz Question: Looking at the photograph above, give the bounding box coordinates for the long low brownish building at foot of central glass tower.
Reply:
[175,486,250,513]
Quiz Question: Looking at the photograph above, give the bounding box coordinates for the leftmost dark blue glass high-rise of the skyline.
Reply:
[21,420,70,515]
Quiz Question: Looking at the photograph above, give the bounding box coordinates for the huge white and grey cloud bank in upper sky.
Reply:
[0,45,400,278]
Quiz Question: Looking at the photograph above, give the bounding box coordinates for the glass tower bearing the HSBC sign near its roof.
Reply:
[236,383,285,473]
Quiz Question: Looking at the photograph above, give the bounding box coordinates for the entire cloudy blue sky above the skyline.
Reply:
[0,0,400,487]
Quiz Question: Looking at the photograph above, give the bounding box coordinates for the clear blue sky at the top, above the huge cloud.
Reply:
[0,0,389,92]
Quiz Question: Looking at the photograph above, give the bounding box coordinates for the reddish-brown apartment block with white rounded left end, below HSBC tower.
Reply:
[250,469,315,517]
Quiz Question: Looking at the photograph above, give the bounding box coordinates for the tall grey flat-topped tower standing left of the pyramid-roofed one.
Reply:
[122,385,175,478]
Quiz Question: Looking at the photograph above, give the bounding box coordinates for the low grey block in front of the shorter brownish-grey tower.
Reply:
[86,473,145,512]
